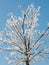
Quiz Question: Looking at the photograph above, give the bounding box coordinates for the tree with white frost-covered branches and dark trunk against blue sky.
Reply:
[0,4,49,65]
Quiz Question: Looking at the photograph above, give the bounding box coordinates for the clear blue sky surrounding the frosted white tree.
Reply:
[0,0,49,65]
